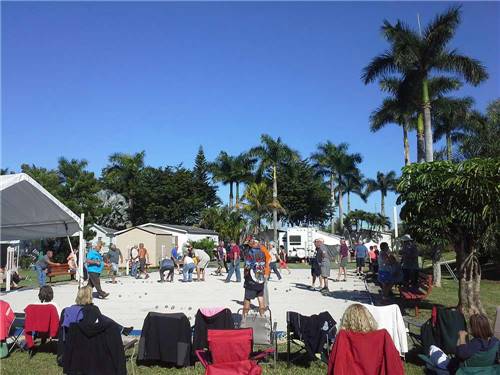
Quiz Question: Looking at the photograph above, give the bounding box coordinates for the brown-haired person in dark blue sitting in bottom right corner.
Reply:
[429,314,500,374]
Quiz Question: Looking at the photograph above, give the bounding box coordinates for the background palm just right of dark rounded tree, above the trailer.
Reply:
[311,141,363,233]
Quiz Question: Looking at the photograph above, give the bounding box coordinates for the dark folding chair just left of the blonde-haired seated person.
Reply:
[286,311,337,367]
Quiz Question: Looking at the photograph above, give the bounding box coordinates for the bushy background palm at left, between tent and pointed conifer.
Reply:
[102,151,146,225]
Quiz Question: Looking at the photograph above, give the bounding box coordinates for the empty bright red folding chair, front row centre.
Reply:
[195,328,274,375]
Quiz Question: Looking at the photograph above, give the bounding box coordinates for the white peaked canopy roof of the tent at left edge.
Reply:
[0,173,80,241]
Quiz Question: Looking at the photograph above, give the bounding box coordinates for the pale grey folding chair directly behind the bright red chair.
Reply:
[237,307,278,367]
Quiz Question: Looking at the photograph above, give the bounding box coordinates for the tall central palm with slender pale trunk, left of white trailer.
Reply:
[248,134,299,243]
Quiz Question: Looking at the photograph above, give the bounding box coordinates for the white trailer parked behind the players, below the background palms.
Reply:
[280,227,342,259]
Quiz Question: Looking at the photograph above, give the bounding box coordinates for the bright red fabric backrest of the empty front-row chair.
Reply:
[208,328,253,363]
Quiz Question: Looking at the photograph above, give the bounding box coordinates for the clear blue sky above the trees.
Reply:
[1,2,500,220]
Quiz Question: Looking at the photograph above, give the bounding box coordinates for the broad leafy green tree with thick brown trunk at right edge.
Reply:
[398,158,500,314]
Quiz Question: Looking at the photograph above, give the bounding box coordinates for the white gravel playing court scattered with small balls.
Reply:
[1,269,370,331]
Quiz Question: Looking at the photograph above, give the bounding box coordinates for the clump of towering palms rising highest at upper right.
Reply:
[362,6,488,165]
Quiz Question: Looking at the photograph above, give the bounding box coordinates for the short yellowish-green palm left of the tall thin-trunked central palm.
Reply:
[243,182,284,234]
